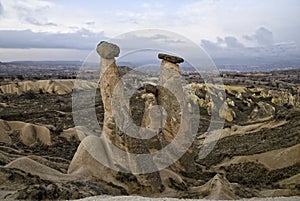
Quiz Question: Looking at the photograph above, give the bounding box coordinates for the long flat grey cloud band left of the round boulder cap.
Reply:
[0,29,107,50]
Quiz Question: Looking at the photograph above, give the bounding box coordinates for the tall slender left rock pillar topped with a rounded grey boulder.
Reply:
[97,41,161,192]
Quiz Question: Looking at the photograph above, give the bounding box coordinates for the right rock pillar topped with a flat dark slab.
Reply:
[157,54,195,172]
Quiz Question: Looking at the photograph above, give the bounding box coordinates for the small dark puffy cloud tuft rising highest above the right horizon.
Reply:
[244,27,274,46]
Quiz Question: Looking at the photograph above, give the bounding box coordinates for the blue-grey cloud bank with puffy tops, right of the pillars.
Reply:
[201,27,300,63]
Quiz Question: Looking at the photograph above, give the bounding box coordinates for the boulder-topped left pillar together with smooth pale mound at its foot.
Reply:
[69,42,162,193]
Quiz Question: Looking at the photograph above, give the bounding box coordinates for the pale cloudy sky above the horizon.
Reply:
[0,0,300,61]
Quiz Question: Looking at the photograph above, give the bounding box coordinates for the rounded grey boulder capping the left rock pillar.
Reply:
[97,41,120,59]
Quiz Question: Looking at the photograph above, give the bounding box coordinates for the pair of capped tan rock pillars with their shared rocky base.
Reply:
[69,48,198,193]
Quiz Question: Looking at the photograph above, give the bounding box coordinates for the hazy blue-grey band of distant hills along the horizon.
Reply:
[0,58,300,73]
